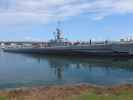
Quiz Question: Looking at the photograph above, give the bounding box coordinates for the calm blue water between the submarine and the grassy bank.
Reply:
[0,51,133,88]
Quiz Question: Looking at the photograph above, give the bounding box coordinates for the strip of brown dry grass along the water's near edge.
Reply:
[0,84,133,100]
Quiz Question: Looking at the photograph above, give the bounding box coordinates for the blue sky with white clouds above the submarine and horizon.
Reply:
[0,0,133,41]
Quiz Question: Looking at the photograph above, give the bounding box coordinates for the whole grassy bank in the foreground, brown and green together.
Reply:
[0,85,133,100]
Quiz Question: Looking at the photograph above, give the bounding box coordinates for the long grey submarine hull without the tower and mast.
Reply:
[4,45,133,57]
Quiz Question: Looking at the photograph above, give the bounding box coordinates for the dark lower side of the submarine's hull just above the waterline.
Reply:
[4,48,133,57]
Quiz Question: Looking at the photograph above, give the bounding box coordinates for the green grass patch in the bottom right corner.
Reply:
[71,92,133,100]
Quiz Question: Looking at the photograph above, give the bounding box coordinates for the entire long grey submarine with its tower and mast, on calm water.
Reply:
[3,28,133,57]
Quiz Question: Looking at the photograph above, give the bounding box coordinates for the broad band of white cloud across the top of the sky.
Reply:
[0,0,133,25]
